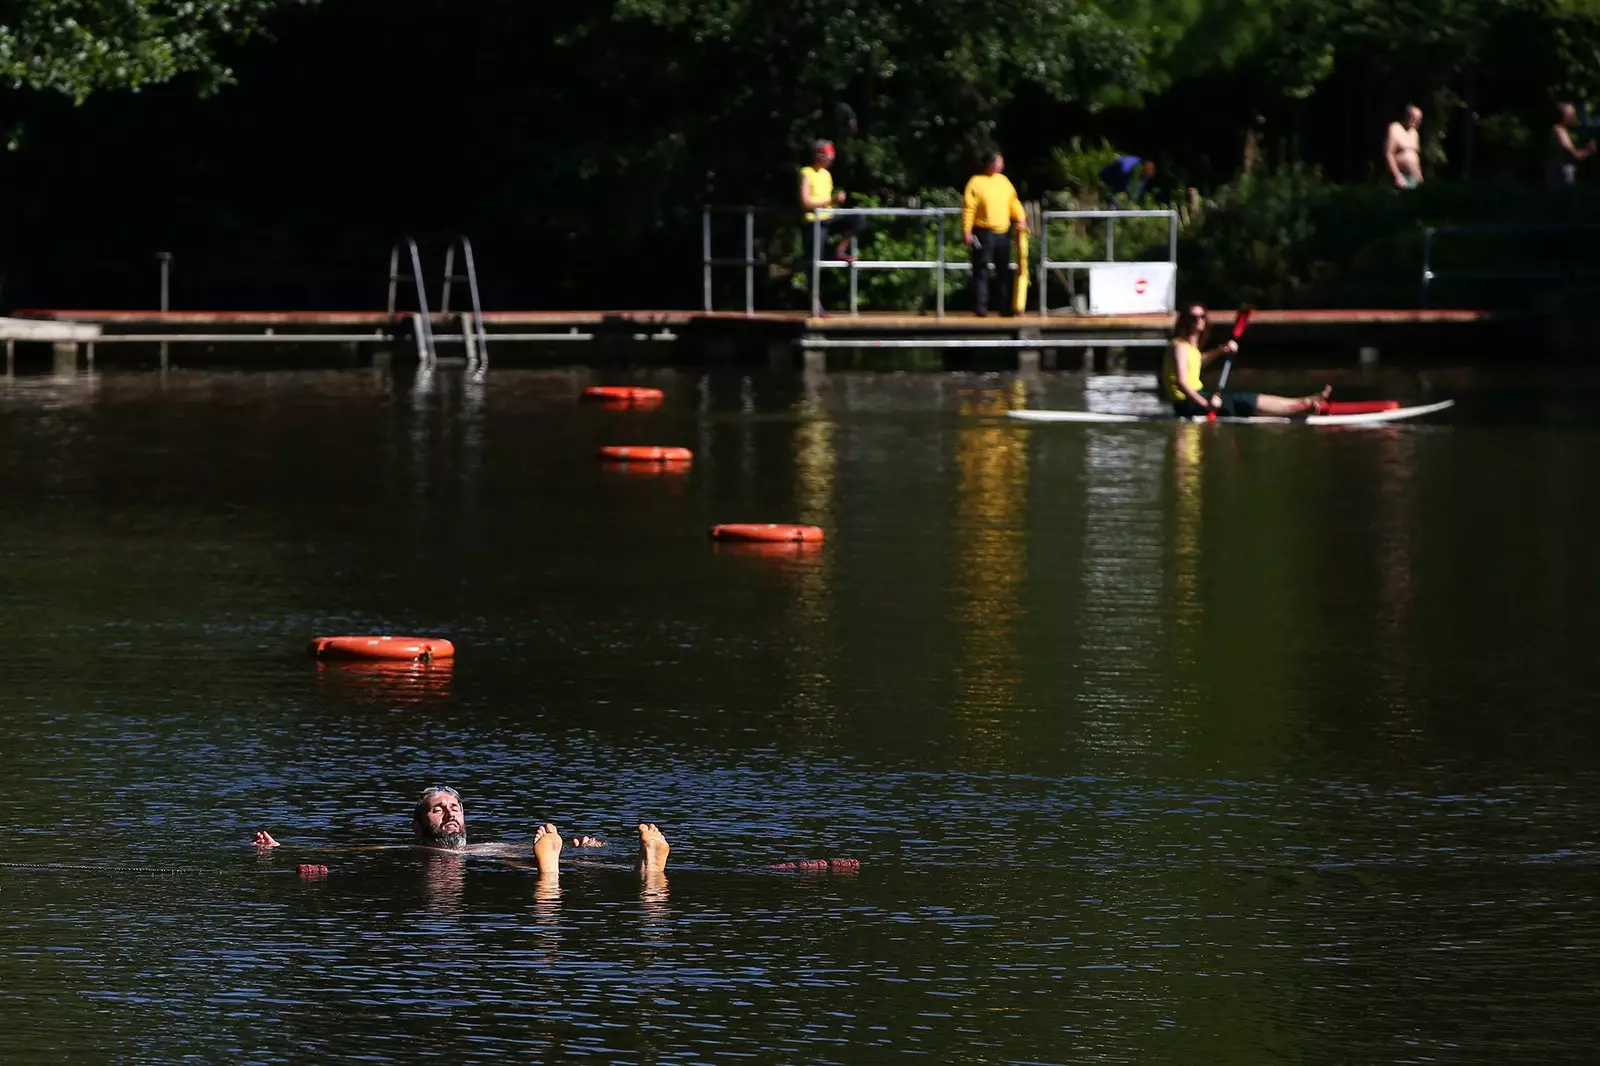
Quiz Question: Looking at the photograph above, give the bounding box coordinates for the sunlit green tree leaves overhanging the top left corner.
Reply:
[0,0,315,102]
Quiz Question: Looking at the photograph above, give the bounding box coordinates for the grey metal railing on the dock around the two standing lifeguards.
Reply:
[701,205,1178,319]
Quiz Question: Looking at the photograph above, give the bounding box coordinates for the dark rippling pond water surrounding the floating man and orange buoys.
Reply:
[0,361,1600,1064]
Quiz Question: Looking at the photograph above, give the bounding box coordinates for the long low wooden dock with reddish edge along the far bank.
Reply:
[0,309,1507,368]
